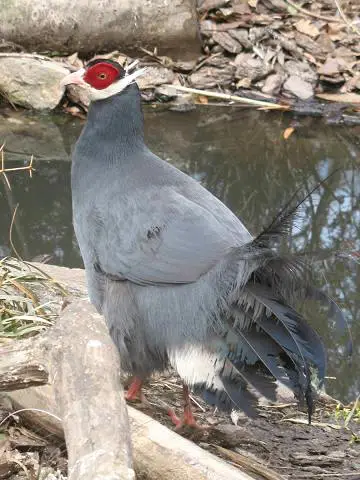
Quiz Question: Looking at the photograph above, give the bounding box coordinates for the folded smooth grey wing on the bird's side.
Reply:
[94,189,245,285]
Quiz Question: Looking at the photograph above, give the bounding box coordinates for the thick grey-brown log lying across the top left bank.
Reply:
[0,0,200,58]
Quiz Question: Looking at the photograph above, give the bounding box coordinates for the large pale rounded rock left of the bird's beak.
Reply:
[0,53,70,110]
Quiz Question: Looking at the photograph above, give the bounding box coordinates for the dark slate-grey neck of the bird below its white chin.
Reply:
[80,84,144,159]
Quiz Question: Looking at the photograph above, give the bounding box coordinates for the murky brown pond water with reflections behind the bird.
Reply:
[0,106,360,400]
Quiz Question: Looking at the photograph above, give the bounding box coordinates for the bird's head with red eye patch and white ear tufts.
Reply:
[60,58,145,101]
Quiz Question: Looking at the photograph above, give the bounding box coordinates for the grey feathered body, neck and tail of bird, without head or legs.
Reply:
[72,69,338,413]
